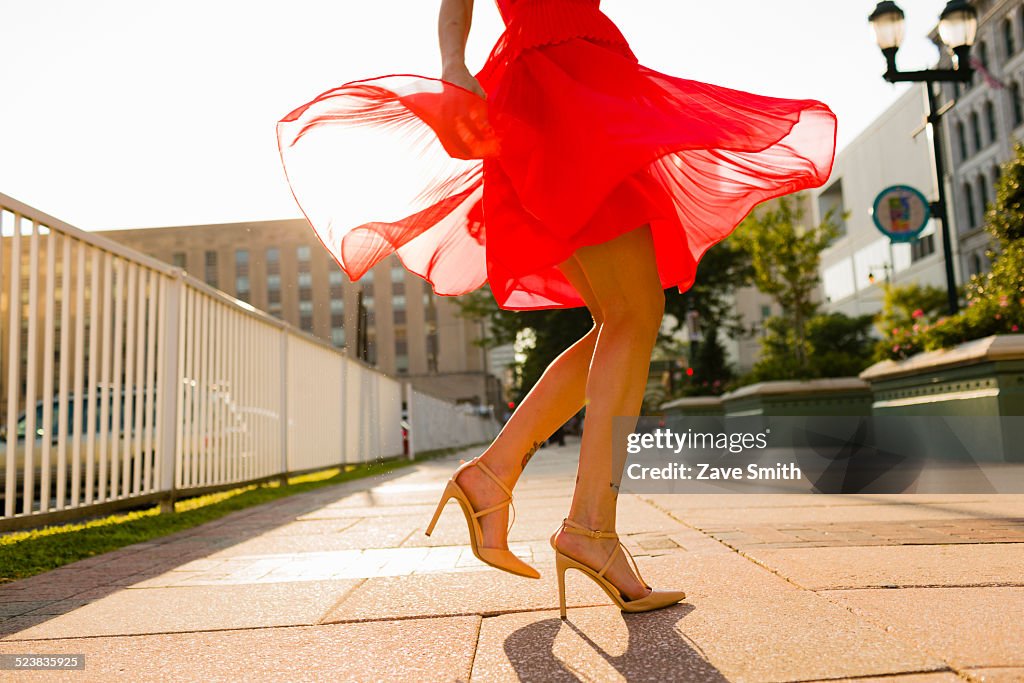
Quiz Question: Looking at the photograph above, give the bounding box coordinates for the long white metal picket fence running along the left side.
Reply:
[0,195,498,529]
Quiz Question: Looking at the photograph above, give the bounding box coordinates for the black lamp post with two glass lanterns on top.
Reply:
[867,0,978,315]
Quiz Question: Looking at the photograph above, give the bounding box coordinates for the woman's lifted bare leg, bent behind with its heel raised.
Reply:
[458,258,601,549]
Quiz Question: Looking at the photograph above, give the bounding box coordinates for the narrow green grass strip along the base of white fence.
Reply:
[0,449,462,584]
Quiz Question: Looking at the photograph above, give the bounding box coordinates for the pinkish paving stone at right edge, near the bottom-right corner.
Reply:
[820,587,1024,670]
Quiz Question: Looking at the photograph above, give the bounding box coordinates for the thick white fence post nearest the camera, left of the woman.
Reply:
[158,270,185,513]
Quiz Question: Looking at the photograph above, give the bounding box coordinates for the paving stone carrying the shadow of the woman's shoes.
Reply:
[473,591,942,683]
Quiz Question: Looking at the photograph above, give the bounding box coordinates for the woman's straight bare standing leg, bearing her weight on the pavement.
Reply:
[556,225,665,599]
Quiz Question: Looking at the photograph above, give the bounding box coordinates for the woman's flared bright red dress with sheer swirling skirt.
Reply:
[278,0,837,310]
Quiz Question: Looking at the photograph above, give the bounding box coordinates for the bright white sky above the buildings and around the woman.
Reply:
[0,0,945,230]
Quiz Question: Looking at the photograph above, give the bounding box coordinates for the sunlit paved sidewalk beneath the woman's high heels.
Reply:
[0,441,1024,683]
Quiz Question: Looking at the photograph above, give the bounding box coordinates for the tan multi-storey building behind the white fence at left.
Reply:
[98,219,501,404]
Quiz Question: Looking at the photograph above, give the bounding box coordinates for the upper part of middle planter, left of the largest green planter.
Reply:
[722,377,871,417]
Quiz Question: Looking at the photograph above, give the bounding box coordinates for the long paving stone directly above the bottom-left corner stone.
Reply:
[5,581,358,640]
